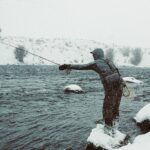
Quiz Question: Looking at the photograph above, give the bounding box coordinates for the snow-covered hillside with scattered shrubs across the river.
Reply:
[0,37,150,67]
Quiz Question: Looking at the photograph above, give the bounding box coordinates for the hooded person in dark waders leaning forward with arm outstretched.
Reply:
[59,48,123,135]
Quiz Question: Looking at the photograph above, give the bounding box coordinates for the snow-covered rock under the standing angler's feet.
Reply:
[87,124,126,150]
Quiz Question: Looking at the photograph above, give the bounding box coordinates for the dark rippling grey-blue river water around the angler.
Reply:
[0,66,150,150]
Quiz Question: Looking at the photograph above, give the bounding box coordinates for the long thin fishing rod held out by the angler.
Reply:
[0,41,60,66]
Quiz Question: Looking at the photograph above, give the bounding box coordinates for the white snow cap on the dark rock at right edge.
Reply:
[134,104,150,123]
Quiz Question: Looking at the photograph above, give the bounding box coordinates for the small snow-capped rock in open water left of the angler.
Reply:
[64,84,83,93]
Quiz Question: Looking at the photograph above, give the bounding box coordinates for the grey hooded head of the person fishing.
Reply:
[91,48,104,60]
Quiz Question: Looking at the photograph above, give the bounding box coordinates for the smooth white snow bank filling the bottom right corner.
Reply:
[113,132,150,150]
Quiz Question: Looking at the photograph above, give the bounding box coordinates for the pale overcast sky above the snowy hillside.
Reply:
[0,0,150,47]
